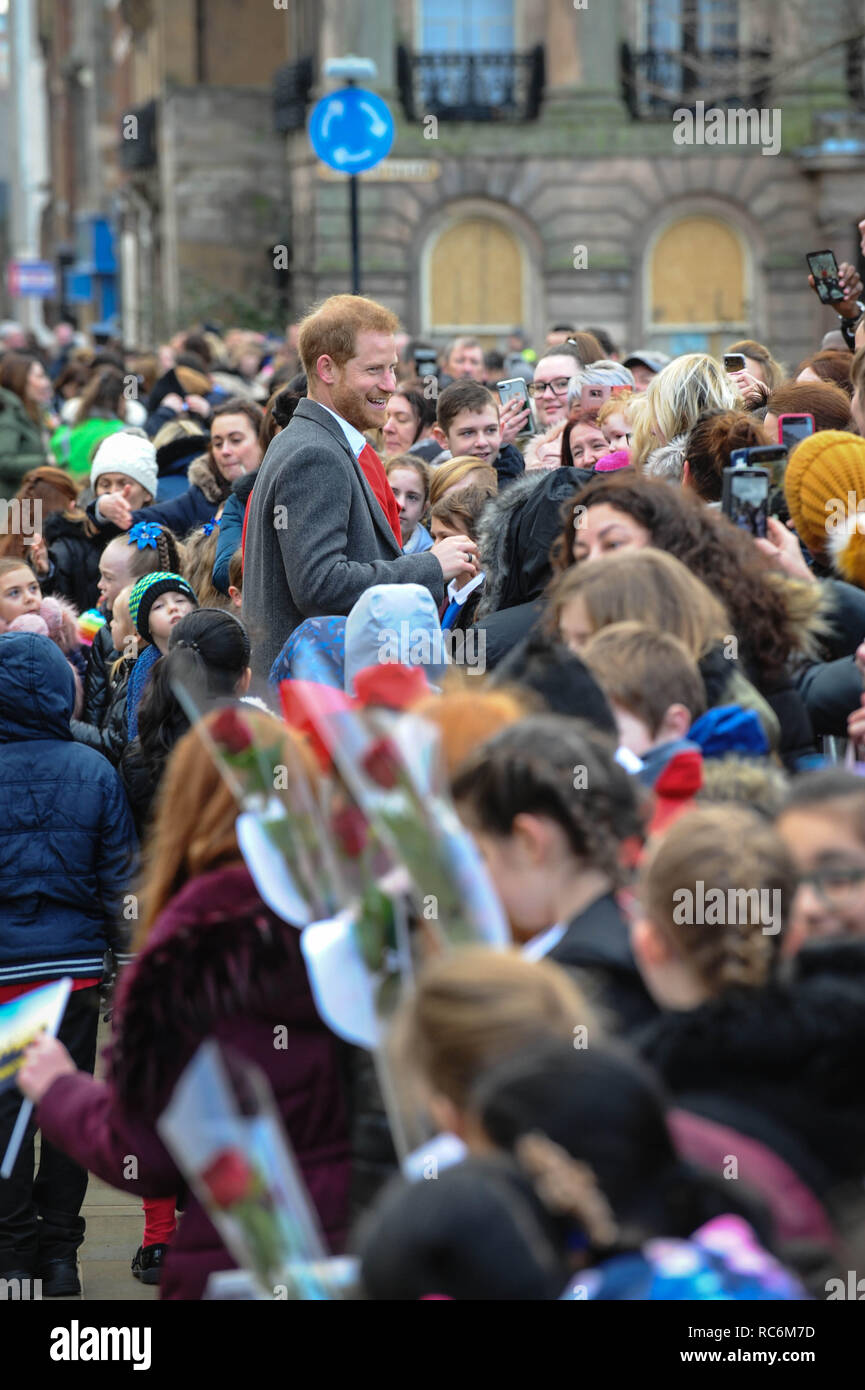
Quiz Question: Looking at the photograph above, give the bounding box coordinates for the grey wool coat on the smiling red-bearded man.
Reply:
[242,400,444,680]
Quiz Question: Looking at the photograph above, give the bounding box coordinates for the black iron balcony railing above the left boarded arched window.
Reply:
[396,44,544,121]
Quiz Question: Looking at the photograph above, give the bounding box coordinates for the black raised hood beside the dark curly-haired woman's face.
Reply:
[476,468,591,620]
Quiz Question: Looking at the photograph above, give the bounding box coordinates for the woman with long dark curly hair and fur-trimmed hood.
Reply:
[553,470,820,765]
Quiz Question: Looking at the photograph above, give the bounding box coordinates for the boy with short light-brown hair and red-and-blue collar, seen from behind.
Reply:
[580,623,706,833]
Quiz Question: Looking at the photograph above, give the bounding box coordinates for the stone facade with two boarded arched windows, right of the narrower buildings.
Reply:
[288,0,865,361]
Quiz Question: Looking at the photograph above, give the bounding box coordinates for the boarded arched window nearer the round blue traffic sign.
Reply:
[424,217,527,338]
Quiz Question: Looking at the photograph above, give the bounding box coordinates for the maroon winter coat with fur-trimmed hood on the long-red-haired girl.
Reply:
[36,865,350,1298]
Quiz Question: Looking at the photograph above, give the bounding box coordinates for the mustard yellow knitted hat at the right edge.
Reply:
[784,430,865,588]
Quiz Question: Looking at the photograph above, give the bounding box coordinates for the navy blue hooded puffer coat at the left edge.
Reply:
[0,632,138,986]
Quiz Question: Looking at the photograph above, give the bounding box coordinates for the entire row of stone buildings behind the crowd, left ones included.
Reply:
[39,0,865,361]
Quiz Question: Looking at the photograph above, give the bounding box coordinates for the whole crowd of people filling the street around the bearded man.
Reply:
[0,221,865,1301]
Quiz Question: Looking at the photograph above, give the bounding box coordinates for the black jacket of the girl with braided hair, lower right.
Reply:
[634,940,865,1201]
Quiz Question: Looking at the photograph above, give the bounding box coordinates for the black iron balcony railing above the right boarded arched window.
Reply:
[622,43,770,121]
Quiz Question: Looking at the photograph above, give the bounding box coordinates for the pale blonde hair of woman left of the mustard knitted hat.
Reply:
[631,352,744,481]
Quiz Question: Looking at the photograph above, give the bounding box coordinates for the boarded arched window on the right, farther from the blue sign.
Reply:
[647,214,750,352]
